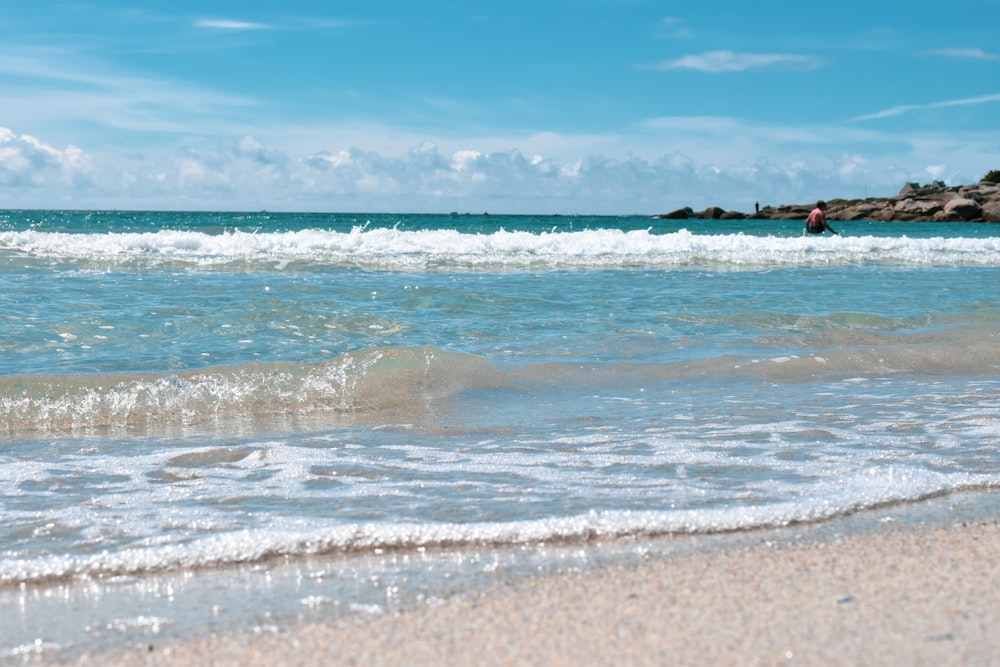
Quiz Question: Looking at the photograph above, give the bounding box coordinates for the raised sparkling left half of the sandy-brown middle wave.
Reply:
[0,347,493,432]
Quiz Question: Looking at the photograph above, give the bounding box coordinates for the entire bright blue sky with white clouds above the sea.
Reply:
[0,0,1000,215]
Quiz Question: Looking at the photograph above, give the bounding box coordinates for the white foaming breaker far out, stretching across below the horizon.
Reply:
[0,227,1000,270]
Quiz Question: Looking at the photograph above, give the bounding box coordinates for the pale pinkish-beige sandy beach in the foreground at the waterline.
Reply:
[72,520,1000,667]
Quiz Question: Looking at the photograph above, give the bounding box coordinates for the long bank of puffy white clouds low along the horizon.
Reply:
[0,117,1000,214]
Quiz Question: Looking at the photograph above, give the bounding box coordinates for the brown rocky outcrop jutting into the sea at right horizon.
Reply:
[656,181,1000,222]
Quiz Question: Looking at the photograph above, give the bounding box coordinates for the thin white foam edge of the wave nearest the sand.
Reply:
[0,467,1000,585]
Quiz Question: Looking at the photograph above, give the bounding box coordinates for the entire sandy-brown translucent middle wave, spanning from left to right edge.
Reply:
[0,321,1000,433]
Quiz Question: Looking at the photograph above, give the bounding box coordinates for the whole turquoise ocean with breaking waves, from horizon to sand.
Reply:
[0,211,1000,664]
